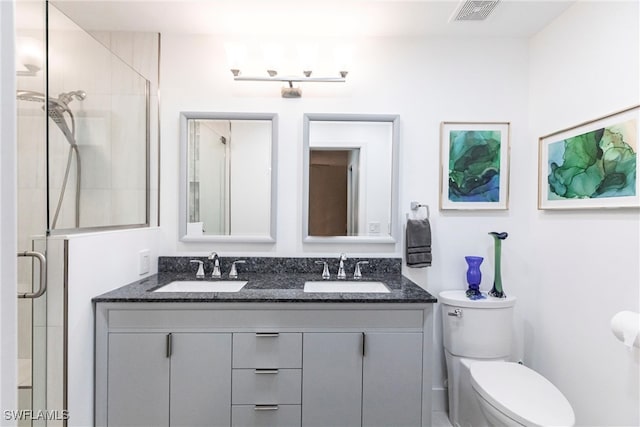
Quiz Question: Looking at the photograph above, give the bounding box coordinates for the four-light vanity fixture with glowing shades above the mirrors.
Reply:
[225,43,353,98]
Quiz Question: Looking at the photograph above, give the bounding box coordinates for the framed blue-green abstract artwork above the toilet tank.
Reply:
[440,122,510,210]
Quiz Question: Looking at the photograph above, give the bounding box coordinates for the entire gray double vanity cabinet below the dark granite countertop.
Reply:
[95,302,433,427]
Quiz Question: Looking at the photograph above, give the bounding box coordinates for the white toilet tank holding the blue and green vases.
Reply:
[438,290,516,358]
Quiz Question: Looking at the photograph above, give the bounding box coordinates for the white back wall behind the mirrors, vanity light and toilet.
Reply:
[160,30,536,407]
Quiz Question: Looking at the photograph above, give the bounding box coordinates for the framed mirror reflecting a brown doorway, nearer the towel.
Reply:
[302,114,400,243]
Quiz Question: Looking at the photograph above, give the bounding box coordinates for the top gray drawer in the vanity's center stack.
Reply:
[233,332,302,369]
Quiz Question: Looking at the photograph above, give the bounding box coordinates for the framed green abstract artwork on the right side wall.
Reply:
[538,106,640,209]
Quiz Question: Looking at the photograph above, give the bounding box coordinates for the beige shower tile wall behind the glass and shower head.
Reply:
[49,5,158,229]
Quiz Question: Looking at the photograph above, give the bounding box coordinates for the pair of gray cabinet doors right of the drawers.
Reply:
[302,332,423,427]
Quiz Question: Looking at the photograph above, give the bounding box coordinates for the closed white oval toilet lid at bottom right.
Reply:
[470,362,575,426]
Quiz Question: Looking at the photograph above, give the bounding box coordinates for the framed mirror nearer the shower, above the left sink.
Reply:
[179,112,278,243]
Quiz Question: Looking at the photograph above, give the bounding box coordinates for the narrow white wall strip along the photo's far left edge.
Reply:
[0,1,18,425]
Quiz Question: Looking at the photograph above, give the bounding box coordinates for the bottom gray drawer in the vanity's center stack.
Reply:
[231,405,302,427]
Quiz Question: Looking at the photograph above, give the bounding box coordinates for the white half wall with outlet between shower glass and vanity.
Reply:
[67,228,159,427]
